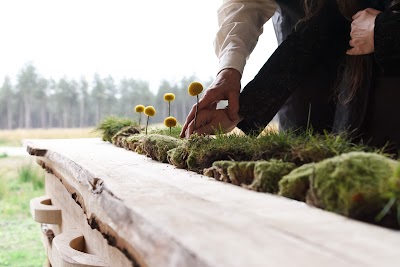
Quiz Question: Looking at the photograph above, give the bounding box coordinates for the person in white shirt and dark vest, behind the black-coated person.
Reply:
[181,0,336,137]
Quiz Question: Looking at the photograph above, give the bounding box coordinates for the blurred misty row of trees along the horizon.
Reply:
[0,64,212,129]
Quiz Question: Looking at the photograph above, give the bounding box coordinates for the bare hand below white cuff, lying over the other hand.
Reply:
[180,69,241,137]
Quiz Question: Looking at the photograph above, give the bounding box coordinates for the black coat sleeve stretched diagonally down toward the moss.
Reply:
[238,1,350,133]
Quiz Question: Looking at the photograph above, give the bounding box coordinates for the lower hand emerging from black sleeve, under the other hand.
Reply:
[184,109,241,138]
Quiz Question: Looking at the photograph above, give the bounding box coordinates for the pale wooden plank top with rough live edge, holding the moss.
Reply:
[25,139,400,266]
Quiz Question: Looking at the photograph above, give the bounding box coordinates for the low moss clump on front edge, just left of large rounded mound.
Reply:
[204,159,296,193]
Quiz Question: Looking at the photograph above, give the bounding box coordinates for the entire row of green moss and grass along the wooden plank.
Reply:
[99,117,400,229]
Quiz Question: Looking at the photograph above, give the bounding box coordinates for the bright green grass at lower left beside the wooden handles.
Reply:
[0,157,46,267]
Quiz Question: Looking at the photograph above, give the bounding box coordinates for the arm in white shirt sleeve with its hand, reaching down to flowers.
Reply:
[180,0,276,137]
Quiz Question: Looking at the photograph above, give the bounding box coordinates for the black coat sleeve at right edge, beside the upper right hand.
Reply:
[374,8,400,76]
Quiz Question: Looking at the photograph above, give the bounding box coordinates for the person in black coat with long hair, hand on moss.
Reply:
[182,0,400,151]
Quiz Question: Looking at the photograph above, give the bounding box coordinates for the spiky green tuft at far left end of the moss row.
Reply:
[95,115,138,142]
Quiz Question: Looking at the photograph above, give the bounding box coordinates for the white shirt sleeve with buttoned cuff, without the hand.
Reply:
[214,0,276,74]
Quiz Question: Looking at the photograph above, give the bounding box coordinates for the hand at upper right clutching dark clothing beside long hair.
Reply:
[346,8,381,56]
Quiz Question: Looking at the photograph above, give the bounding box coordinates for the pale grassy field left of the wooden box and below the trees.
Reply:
[0,128,98,267]
